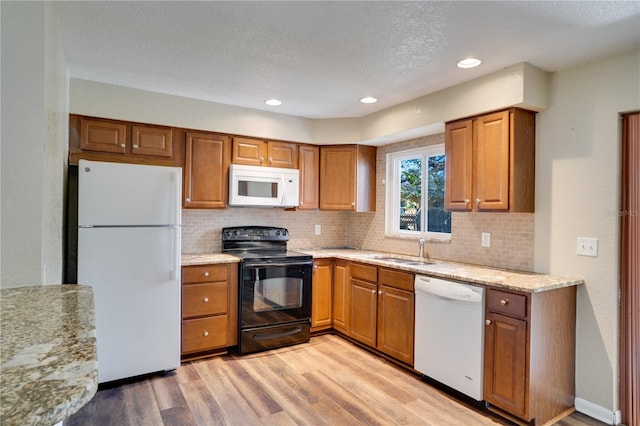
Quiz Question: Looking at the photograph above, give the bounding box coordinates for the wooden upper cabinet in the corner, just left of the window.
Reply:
[320,145,376,212]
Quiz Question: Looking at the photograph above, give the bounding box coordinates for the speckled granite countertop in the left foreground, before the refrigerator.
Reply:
[0,284,98,425]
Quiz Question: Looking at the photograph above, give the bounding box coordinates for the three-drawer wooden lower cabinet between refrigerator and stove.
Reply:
[181,263,238,359]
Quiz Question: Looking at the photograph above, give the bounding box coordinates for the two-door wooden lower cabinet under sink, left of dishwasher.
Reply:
[349,263,415,365]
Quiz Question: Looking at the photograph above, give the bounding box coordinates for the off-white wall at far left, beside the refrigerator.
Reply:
[0,2,68,287]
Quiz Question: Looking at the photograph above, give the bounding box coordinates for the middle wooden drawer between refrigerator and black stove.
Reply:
[182,282,229,318]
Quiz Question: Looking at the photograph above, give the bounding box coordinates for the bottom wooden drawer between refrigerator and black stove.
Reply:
[182,315,228,353]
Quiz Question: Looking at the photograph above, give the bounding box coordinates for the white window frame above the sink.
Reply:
[385,143,451,241]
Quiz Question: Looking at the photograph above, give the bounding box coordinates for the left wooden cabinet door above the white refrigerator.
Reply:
[80,118,127,154]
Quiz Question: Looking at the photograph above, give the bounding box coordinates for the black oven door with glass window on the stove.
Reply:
[240,261,313,328]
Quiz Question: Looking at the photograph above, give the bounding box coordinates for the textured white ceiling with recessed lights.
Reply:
[56,1,640,118]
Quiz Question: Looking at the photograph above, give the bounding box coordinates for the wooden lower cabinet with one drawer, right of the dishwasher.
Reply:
[484,287,576,424]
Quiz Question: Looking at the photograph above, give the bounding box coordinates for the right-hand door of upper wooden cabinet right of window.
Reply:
[474,111,509,210]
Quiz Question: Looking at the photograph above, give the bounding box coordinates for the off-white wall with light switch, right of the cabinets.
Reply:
[534,50,640,422]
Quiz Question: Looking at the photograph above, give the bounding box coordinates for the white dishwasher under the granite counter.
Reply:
[414,275,484,401]
